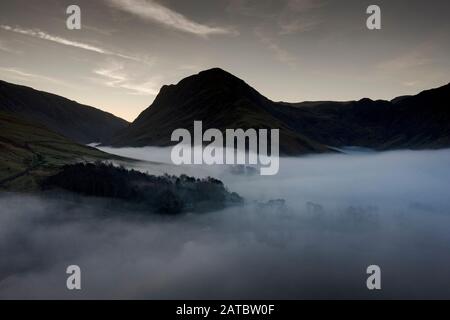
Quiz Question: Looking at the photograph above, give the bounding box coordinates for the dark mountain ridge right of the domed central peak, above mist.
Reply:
[274,84,450,150]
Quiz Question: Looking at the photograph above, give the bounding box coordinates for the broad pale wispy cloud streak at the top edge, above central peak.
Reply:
[105,0,237,37]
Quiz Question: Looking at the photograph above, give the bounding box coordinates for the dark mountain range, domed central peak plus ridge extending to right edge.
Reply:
[110,68,450,155]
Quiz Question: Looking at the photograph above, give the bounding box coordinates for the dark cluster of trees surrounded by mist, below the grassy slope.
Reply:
[42,162,243,214]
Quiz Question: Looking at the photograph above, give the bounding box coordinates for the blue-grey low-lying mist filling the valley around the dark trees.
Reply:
[0,148,450,299]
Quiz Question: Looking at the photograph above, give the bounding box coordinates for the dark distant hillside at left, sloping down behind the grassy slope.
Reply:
[0,81,128,144]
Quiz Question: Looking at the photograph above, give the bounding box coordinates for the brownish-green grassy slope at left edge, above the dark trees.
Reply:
[0,112,115,191]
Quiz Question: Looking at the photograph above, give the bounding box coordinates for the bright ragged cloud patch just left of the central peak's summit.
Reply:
[93,61,160,96]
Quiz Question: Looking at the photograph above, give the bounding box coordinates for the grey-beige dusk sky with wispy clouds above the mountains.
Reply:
[0,0,450,121]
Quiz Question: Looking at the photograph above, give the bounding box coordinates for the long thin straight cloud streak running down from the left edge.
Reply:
[0,25,139,61]
